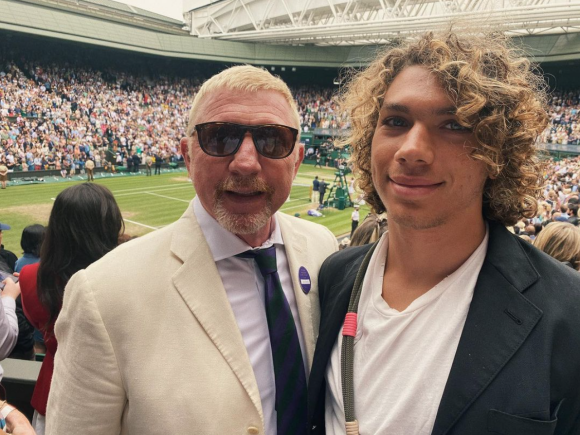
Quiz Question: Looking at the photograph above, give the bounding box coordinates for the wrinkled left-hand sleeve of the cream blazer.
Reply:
[46,270,127,435]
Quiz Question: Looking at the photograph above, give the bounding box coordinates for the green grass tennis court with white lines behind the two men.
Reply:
[0,165,369,257]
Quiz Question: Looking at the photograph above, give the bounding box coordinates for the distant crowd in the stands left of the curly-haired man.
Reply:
[0,55,349,177]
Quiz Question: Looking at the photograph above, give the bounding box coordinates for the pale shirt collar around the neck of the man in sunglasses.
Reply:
[192,196,284,261]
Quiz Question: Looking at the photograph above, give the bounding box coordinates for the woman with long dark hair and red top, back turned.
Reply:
[20,183,124,435]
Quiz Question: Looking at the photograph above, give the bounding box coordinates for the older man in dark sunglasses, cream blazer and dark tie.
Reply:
[47,66,337,435]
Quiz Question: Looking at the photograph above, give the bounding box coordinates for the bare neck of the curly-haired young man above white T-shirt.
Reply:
[383,217,486,311]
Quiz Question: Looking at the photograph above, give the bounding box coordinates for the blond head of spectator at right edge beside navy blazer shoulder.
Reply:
[534,222,580,270]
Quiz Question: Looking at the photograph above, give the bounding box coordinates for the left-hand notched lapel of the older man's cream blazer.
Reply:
[171,209,264,422]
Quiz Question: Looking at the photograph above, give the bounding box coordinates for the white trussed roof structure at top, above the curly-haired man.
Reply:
[184,0,580,45]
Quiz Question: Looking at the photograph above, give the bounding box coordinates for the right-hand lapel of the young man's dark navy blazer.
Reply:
[432,223,542,435]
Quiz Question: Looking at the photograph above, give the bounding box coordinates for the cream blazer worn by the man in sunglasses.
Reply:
[46,206,337,435]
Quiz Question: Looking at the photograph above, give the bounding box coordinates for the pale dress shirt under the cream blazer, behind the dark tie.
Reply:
[193,196,309,435]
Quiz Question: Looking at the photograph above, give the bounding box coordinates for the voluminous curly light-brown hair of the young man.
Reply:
[339,31,548,225]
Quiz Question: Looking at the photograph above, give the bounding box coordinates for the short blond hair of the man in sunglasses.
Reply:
[186,65,300,136]
